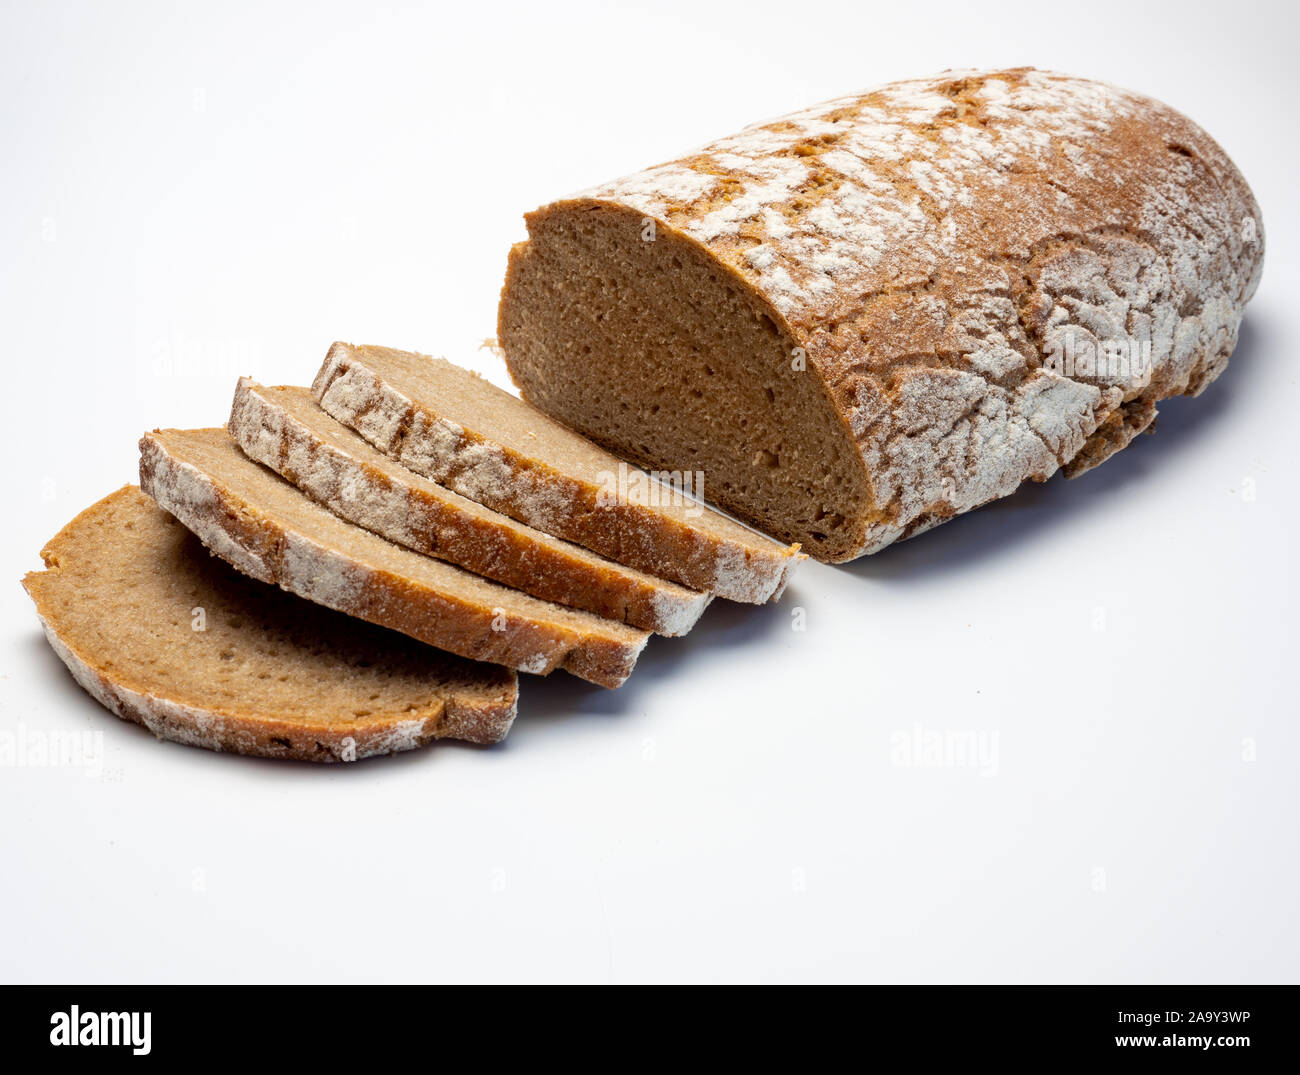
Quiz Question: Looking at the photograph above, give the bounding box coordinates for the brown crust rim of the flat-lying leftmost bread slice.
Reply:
[23,485,519,762]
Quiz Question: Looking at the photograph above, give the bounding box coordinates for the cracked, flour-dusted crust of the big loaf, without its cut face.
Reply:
[538,69,1264,559]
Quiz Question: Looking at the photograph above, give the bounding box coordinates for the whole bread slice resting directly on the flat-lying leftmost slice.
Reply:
[140,429,649,686]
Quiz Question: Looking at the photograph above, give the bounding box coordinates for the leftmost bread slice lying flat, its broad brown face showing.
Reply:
[22,485,517,762]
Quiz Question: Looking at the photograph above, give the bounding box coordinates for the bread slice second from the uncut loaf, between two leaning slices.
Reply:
[230,377,710,634]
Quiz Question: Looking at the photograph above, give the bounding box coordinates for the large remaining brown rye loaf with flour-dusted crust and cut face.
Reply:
[498,69,1264,562]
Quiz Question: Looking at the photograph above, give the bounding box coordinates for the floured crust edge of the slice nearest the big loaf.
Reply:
[312,342,803,603]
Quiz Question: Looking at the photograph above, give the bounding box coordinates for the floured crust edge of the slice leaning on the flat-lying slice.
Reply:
[140,430,649,688]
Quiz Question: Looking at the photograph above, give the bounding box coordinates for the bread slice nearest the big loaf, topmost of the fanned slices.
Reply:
[312,343,802,603]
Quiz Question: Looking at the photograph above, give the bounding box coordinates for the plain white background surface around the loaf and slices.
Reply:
[0,0,1300,983]
